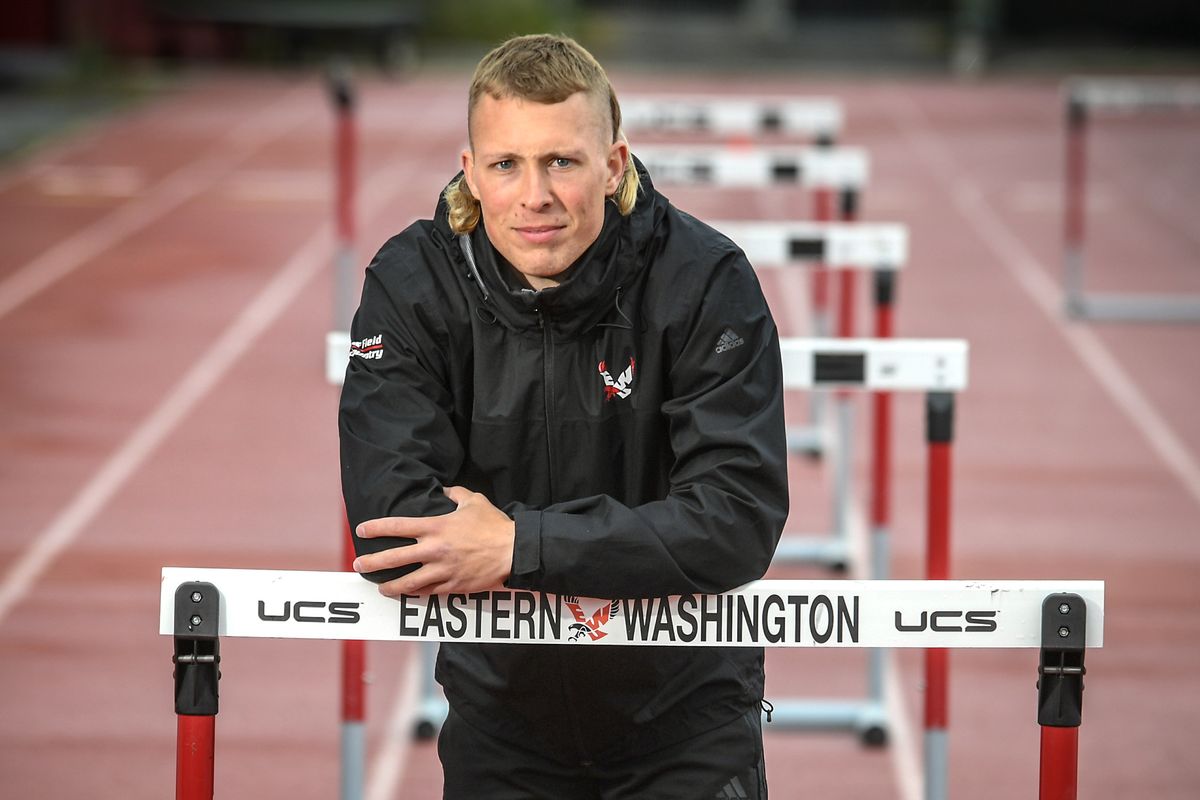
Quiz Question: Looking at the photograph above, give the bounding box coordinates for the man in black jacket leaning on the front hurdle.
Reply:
[340,36,787,800]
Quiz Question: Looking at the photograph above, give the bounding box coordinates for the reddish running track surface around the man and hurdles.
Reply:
[0,72,1200,800]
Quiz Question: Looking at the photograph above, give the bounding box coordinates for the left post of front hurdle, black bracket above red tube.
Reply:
[172,583,221,800]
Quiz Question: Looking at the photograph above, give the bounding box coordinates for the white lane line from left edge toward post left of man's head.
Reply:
[0,146,432,624]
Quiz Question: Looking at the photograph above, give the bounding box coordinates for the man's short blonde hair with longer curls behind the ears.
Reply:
[443,34,641,234]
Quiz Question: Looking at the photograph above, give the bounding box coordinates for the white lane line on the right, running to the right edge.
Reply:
[886,92,1200,513]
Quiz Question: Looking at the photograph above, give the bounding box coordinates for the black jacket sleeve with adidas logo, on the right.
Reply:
[509,251,787,599]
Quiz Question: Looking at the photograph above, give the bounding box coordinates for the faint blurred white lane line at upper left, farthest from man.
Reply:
[0,86,316,317]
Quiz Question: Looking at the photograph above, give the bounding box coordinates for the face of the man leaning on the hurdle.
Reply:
[462,92,629,289]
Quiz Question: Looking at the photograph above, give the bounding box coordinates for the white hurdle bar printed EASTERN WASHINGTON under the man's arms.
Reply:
[158,567,1104,649]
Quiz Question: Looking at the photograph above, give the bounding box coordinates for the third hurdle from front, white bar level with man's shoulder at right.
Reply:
[712,222,908,578]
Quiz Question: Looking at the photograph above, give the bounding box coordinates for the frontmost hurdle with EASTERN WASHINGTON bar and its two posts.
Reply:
[158,567,1104,800]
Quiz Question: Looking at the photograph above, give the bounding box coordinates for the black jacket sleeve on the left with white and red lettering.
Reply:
[338,247,463,583]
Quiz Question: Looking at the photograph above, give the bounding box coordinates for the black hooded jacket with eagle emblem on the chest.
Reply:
[340,160,787,763]
